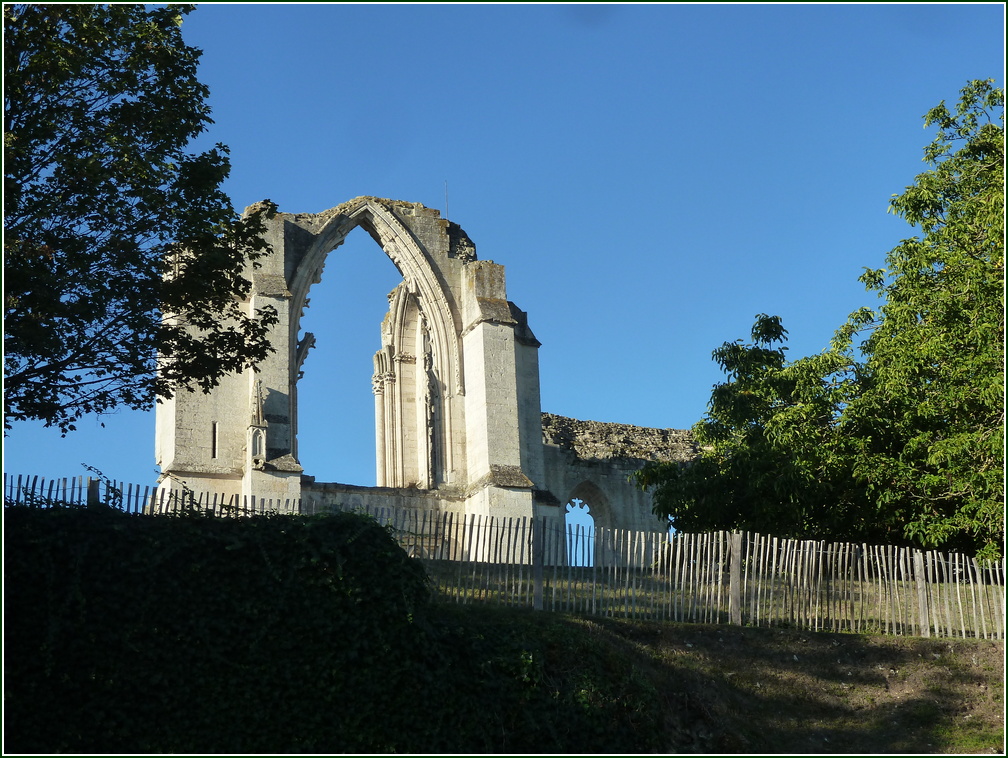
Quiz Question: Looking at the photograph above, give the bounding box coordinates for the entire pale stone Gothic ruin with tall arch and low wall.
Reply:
[155,198,696,531]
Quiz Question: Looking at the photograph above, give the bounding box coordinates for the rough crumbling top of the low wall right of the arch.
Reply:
[542,413,700,462]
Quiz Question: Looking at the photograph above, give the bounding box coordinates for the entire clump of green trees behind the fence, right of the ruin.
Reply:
[636,82,1004,557]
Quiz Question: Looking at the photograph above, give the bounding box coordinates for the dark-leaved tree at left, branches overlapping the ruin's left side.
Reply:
[4,5,276,433]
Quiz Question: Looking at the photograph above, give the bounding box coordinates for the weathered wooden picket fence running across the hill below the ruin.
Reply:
[4,474,1006,639]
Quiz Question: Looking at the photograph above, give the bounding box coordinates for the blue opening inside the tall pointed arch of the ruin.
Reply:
[296,229,402,487]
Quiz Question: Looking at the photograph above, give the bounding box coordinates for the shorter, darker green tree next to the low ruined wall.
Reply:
[636,313,891,540]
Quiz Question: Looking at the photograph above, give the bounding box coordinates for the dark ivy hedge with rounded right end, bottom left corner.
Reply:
[4,507,428,754]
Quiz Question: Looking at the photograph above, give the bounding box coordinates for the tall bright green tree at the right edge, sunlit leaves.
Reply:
[841,81,1005,555]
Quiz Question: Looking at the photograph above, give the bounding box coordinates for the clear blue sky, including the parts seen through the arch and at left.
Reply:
[4,3,1005,485]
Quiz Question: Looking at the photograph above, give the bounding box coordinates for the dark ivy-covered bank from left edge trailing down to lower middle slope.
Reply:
[4,507,667,753]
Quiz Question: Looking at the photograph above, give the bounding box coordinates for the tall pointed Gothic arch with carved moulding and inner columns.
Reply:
[288,198,464,489]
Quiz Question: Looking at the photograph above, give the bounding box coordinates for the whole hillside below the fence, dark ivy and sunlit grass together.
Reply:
[4,508,1004,755]
